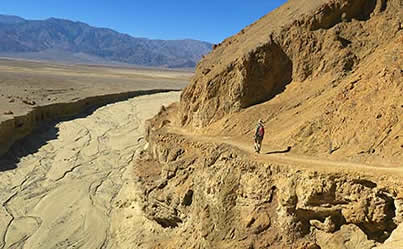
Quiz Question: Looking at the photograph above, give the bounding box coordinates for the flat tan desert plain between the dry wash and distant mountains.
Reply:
[0,58,193,122]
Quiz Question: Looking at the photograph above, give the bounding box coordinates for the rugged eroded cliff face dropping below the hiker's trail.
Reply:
[135,120,402,248]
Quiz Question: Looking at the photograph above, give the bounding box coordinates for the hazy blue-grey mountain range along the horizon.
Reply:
[0,15,212,68]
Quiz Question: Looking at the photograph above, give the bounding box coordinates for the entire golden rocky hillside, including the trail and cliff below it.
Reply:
[128,0,403,249]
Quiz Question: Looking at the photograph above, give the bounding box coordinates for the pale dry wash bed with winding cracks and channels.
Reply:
[0,92,179,249]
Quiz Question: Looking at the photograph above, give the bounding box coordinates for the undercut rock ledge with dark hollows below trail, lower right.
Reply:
[282,174,397,242]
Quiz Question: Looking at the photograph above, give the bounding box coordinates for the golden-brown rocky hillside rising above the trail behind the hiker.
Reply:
[180,0,403,162]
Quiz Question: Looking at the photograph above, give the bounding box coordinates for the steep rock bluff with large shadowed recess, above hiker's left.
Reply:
[181,41,292,127]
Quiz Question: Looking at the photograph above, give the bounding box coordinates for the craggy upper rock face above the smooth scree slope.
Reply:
[180,0,400,127]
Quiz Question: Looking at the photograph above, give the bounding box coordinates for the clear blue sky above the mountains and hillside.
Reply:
[0,0,286,43]
